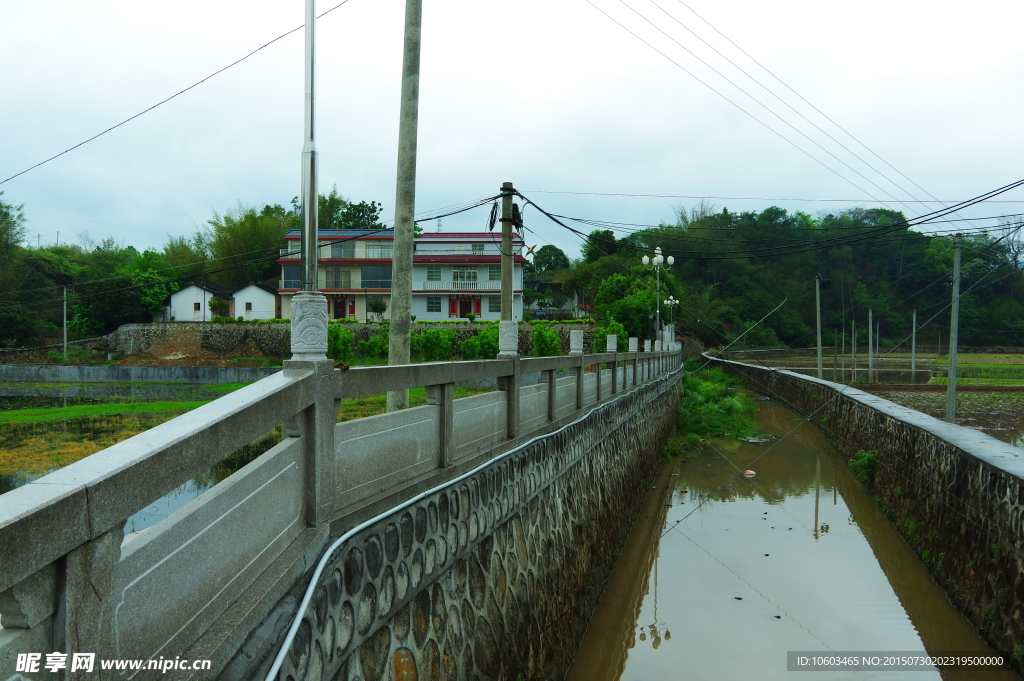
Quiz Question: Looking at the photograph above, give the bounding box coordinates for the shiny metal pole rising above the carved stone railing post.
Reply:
[300,0,318,293]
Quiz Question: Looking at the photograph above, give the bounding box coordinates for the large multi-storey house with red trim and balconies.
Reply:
[279,229,523,320]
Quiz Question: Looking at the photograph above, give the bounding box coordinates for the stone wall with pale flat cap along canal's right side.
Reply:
[710,357,1024,672]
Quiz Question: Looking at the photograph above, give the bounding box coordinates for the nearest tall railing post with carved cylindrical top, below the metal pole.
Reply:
[283,291,338,526]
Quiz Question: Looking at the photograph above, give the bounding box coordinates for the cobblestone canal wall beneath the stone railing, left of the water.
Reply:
[255,372,682,681]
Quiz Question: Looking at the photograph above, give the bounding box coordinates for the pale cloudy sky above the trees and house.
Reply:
[0,0,1024,257]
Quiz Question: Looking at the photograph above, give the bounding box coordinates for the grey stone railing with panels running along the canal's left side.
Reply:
[0,307,682,679]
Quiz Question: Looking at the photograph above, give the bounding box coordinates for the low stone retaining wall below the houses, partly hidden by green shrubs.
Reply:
[99,322,595,357]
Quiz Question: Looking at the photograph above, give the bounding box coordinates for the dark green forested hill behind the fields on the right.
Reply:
[563,207,1024,347]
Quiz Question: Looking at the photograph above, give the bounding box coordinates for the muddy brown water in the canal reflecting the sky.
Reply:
[567,400,1017,681]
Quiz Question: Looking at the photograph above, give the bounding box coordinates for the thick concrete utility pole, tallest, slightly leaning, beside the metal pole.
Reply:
[387,0,423,412]
